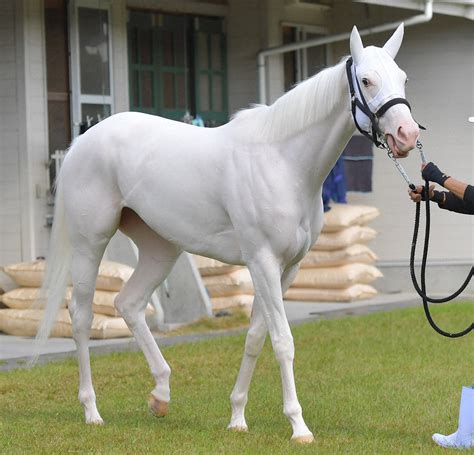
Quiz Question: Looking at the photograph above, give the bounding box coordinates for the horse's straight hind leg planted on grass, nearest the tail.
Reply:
[63,181,121,424]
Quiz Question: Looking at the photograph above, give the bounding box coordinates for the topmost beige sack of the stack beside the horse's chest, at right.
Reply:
[323,204,380,232]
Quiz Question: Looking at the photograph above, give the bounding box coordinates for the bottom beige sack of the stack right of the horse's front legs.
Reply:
[285,284,377,302]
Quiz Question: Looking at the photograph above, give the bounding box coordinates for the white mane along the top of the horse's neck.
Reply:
[231,62,345,142]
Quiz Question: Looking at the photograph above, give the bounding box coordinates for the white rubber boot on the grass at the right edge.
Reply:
[433,387,474,449]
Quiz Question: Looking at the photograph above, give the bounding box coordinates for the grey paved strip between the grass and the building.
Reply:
[0,294,420,370]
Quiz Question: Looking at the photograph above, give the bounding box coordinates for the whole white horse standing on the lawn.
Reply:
[38,26,419,443]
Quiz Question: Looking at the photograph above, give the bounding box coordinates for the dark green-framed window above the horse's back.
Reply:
[128,10,227,126]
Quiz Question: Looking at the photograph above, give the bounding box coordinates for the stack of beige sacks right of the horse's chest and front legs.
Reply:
[285,204,382,302]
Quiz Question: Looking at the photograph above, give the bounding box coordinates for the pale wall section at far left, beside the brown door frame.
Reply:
[0,0,48,264]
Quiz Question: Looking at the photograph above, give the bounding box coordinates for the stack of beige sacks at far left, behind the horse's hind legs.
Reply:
[0,260,141,339]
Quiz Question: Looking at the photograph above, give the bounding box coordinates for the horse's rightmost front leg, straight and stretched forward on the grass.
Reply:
[248,253,314,443]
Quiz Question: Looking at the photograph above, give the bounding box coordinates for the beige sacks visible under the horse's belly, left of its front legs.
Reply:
[194,256,254,315]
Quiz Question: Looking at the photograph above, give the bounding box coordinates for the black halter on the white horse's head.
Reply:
[346,57,425,148]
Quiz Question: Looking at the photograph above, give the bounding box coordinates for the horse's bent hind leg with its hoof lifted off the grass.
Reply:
[115,209,181,417]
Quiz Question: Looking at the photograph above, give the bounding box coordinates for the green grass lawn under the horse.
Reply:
[0,303,474,454]
